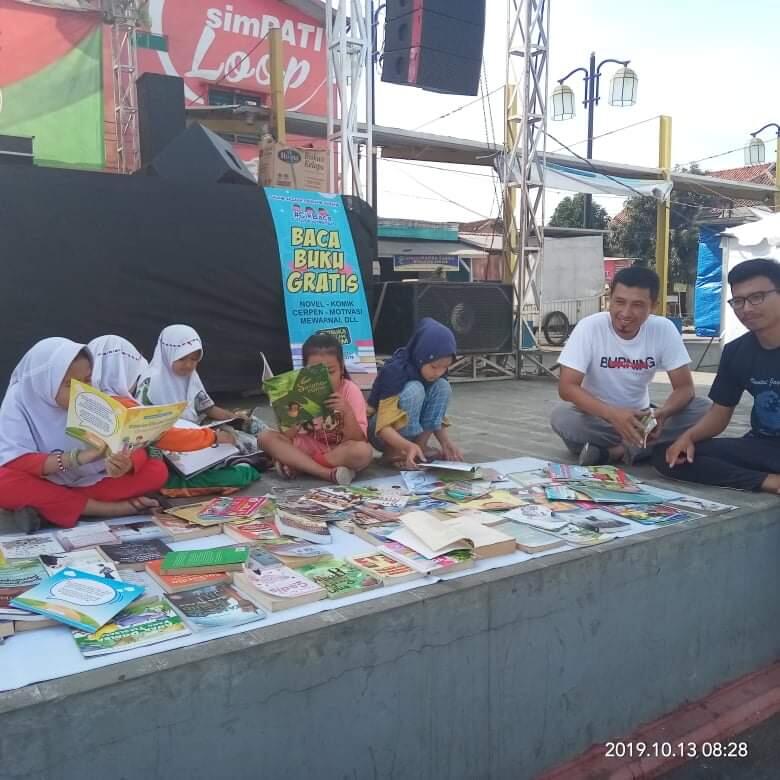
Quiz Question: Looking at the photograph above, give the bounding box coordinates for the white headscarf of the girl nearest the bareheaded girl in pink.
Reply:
[135,325,214,422]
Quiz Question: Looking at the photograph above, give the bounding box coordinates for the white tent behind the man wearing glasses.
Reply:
[720,214,780,344]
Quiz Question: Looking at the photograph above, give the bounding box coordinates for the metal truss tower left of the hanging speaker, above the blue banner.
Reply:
[325,0,374,203]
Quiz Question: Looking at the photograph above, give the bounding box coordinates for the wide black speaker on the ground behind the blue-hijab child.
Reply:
[374,281,512,355]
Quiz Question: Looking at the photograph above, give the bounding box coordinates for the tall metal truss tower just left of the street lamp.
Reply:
[501,0,550,376]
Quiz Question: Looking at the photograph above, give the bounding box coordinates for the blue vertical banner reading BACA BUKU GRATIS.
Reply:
[265,187,376,388]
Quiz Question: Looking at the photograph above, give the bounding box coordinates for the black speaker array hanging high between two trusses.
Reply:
[382,0,485,95]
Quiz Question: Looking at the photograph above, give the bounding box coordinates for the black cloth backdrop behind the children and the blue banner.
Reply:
[0,165,376,394]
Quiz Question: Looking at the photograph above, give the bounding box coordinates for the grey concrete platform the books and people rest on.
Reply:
[0,380,780,780]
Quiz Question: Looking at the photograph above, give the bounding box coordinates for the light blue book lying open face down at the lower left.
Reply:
[11,569,143,633]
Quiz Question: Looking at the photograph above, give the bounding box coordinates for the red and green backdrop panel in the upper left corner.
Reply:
[0,0,103,168]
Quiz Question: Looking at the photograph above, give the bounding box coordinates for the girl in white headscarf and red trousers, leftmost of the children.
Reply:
[0,338,168,531]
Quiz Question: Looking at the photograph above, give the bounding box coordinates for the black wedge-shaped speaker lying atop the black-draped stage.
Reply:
[147,122,257,186]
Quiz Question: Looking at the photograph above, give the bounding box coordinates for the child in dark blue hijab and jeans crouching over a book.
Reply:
[368,317,463,468]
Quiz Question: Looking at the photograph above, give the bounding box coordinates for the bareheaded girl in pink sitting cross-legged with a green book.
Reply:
[260,333,374,485]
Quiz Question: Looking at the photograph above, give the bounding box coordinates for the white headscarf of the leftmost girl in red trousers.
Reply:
[0,338,106,486]
